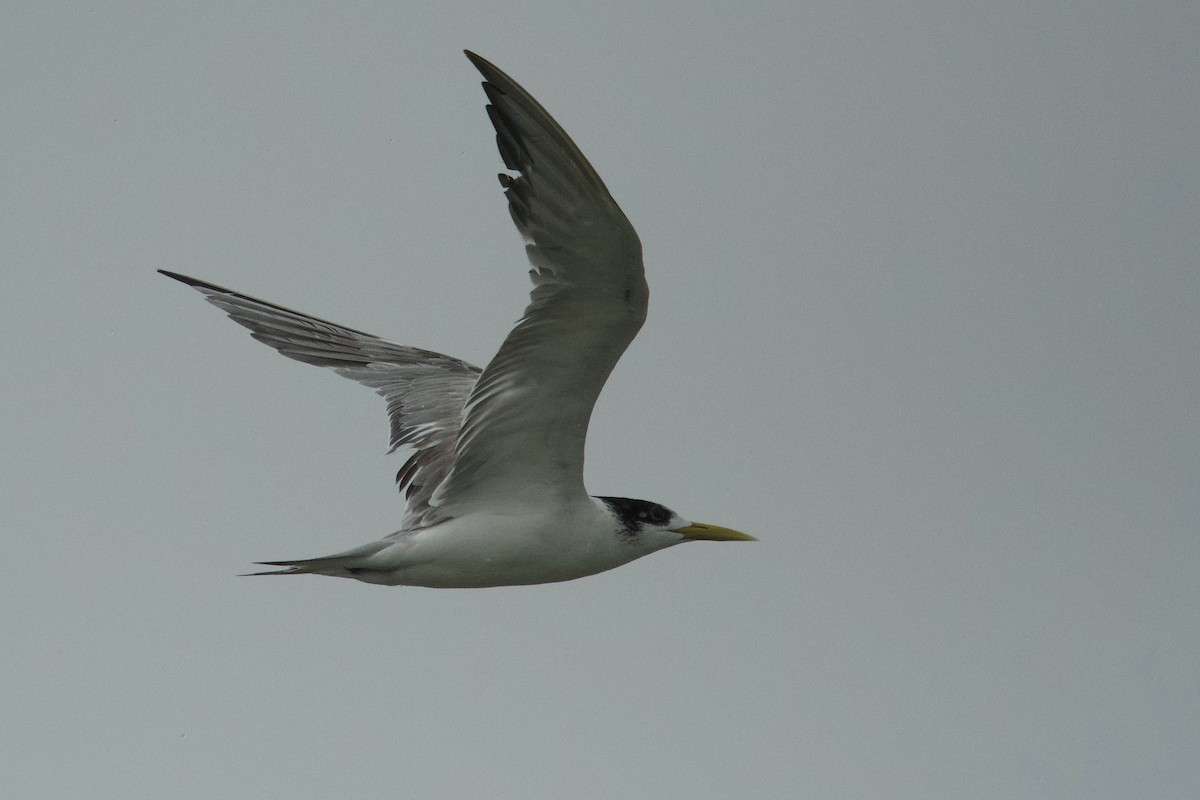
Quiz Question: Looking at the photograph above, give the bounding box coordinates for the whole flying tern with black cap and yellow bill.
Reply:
[160,50,754,588]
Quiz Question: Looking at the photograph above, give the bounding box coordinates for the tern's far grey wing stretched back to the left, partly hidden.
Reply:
[158,270,479,529]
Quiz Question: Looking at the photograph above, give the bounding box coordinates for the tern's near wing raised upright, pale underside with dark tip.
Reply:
[432,52,649,513]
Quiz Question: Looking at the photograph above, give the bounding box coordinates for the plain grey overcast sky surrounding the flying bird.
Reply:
[0,0,1200,800]
